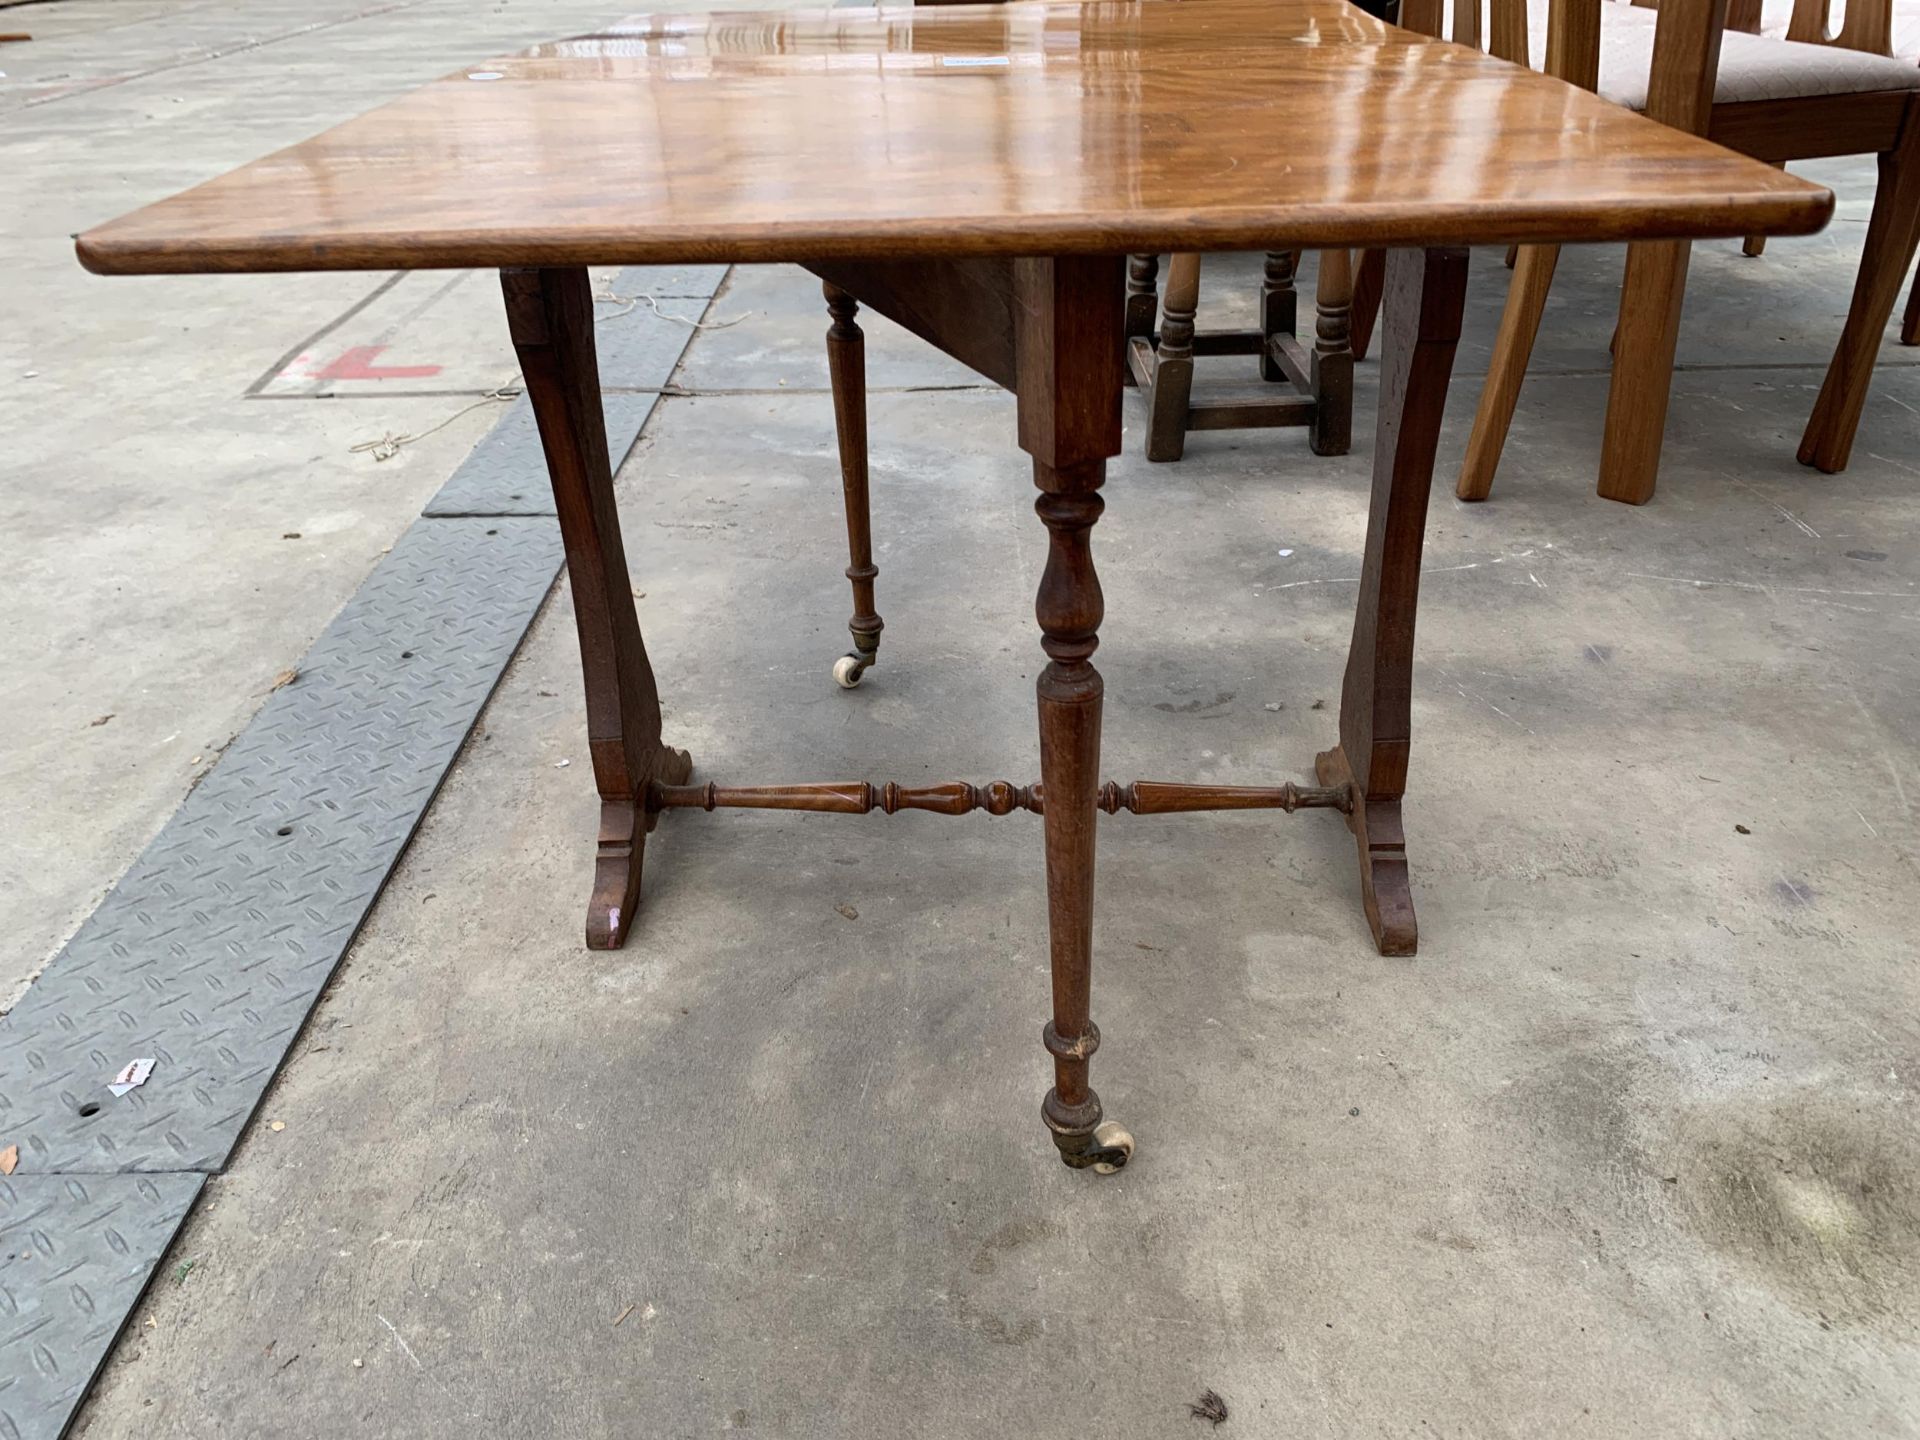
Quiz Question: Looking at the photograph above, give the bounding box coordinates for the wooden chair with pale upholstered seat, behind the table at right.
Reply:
[1455,0,1920,505]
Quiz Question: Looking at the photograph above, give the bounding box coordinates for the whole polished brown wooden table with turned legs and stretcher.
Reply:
[79,0,1834,1169]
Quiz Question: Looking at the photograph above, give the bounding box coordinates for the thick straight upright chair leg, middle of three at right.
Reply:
[1599,240,1692,505]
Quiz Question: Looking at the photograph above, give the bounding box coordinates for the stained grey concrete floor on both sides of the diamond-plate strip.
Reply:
[0,0,1920,1440]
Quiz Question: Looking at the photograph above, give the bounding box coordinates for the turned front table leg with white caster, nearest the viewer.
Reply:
[1014,257,1133,1171]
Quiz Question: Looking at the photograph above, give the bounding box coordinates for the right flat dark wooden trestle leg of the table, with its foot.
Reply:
[1315,250,1467,954]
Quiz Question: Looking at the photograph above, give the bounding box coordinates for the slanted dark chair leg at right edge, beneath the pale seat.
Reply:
[1799,122,1920,474]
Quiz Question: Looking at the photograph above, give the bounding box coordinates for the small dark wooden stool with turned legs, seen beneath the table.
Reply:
[1127,250,1354,461]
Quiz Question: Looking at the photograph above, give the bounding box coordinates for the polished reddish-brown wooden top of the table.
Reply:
[79,0,1834,273]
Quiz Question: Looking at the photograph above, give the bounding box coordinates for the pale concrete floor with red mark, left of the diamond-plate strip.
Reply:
[0,0,733,1010]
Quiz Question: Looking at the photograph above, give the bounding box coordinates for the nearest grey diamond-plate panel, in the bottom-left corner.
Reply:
[0,1175,205,1440]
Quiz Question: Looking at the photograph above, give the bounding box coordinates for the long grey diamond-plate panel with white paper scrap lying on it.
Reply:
[0,516,561,1173]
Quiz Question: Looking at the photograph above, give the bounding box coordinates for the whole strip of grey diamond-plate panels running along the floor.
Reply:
[0,265,726,1440]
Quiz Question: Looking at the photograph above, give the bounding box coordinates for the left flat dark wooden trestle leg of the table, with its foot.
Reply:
[499,269,693,950]
